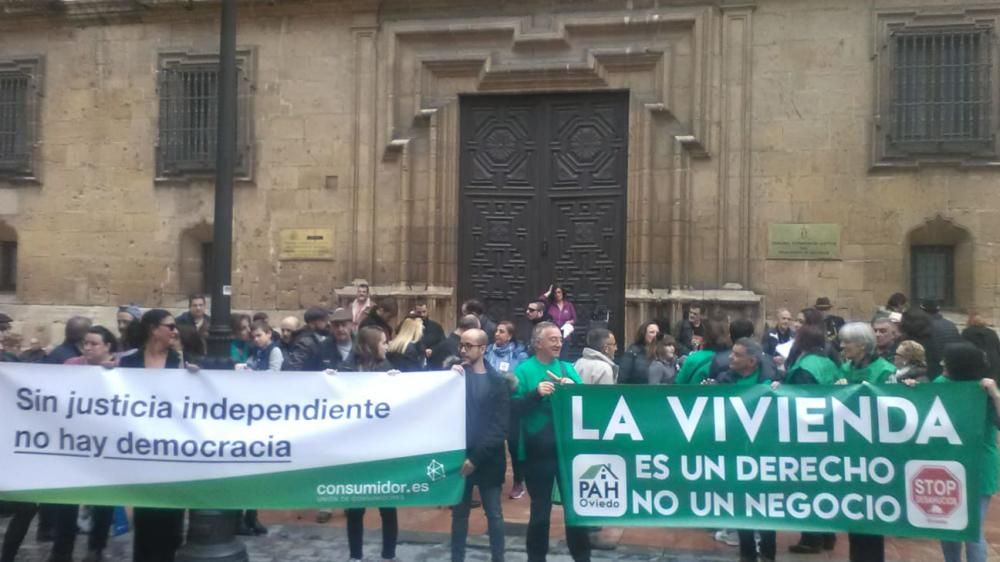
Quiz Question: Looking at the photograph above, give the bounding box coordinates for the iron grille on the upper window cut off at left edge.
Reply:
[0,71,35,176]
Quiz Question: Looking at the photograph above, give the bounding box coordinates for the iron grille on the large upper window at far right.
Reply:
[889,27,993,154]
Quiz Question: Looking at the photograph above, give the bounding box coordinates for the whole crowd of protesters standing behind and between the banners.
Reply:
[0,285,1000,562]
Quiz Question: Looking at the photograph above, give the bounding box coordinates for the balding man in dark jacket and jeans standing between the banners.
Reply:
[451,328,510,562]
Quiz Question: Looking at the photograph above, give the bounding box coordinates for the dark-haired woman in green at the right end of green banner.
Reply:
[934,342,1000,562]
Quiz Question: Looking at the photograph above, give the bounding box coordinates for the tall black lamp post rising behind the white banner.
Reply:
[176,0,248,562]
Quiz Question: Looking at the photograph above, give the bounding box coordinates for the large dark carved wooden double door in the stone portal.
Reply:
[458,92,628,349]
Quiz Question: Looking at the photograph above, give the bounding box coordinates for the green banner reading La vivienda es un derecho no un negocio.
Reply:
[552,383,987,540]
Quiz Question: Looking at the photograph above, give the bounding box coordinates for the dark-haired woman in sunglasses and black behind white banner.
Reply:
[119,308,184,562]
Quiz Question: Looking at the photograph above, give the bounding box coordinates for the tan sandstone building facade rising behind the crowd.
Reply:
[0,0,1000,339]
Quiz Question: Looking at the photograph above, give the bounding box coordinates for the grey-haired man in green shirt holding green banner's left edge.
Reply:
[511,322,590,562]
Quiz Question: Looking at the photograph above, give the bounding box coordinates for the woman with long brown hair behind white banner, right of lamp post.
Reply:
[334,325,399,561]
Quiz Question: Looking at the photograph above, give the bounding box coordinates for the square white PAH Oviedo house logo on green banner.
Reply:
[573,455,628,517]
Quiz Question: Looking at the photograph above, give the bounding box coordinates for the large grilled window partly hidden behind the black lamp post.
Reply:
[156,51,253,178]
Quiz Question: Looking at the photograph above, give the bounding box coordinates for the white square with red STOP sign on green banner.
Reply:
[905,460,969,531]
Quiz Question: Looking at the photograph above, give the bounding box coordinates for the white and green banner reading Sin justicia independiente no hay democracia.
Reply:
[0,363,465,509]
